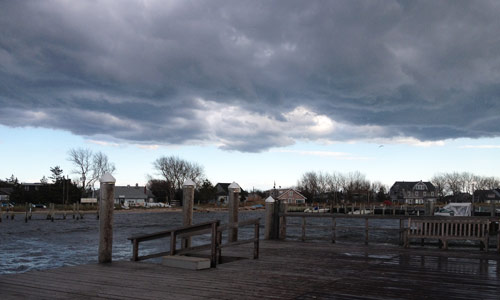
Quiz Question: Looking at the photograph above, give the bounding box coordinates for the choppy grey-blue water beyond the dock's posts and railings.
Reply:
[0,210,408,274]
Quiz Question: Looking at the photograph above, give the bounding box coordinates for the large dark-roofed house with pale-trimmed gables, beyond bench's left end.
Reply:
[389,181,438,204]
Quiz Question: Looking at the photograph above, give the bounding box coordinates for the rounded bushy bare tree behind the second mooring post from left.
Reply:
[153,156,204,200]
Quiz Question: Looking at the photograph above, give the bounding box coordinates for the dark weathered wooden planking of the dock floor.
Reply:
[0,241,500,299]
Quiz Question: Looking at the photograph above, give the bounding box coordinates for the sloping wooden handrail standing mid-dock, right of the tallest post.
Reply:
[128,219,260,268]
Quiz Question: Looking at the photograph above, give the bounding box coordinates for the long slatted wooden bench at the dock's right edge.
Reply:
[404,217,491,251]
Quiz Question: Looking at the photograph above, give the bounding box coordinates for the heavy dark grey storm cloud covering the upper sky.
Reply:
[0,1,500,152]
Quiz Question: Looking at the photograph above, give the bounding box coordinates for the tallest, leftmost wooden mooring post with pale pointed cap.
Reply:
[99,173,116,263]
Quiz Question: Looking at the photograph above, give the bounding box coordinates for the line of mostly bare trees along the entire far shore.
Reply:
[0,148,500,204]
